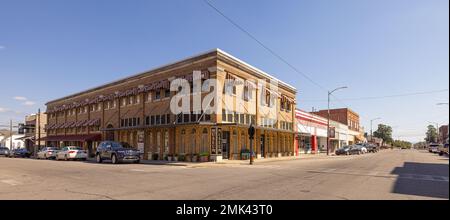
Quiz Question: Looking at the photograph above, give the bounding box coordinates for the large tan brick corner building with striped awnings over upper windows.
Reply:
[46,49,296,159]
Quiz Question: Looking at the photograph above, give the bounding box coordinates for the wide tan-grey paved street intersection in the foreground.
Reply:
[0,150,449,200]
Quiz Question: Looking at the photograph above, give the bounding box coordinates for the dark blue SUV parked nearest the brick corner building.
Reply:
[95,141,141,164]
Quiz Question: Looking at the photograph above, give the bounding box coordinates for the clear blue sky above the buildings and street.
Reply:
[0,0,449,141]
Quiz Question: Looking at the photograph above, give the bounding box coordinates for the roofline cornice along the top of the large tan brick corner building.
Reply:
[46,48,297,105]
